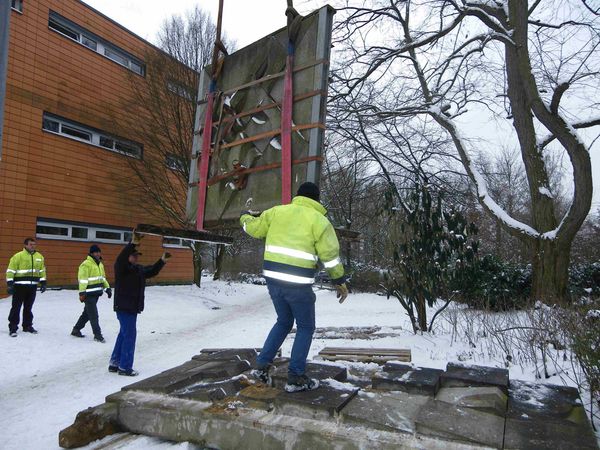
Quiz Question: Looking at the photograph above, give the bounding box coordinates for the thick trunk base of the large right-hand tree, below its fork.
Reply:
[531,239,570,305]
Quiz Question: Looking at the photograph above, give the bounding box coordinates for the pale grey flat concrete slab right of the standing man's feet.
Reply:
[340,391,429,434]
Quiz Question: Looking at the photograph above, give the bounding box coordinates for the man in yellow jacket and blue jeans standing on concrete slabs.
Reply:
[240,182,348,392]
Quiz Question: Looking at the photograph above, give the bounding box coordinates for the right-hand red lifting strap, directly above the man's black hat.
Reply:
[281,42,294,205]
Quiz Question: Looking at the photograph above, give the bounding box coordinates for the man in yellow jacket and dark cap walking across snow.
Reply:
[71,244,112,343]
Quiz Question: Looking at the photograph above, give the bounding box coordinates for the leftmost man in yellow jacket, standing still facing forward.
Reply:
[6,238,46,337]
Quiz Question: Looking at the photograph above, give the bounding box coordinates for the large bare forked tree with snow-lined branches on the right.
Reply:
[334,0,600,302]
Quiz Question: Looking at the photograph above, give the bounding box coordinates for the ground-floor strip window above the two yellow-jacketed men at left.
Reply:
[36,218,131,244]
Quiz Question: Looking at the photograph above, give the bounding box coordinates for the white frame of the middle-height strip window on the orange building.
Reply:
[42,111,144,159]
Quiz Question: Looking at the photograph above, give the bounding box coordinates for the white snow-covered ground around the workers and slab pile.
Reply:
[0,279,596,450]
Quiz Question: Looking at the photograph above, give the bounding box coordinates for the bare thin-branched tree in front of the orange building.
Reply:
[109,6,229,286]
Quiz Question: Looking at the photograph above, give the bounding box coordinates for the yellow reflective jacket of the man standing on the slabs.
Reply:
[240,196,344,284]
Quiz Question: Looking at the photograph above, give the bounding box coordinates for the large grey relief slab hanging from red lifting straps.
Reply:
[187,6,334,227]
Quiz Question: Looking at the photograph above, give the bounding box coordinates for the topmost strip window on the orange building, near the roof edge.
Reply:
[48,11,145,76]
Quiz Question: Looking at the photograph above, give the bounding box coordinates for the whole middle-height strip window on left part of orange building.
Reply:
[42,112,143,159]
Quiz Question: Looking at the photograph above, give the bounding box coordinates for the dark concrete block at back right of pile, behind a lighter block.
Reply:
[440,363,509,395]
